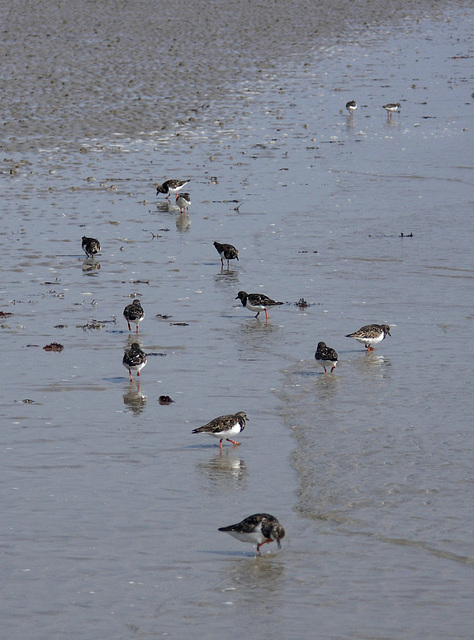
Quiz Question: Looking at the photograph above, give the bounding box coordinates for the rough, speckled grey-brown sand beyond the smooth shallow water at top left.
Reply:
[2,0,470,151]
